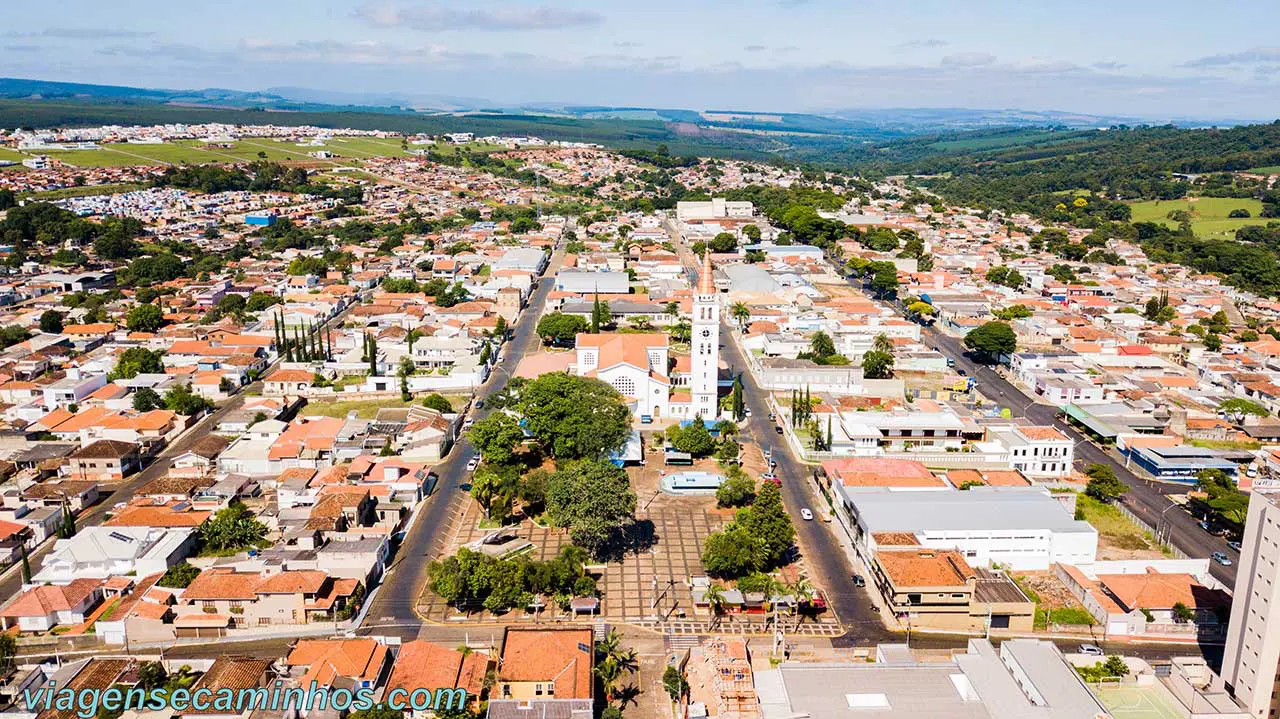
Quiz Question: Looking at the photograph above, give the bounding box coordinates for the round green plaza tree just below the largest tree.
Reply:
[535,458,636,557]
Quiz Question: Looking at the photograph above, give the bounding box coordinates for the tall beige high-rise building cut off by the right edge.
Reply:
[1222,494,1280,716]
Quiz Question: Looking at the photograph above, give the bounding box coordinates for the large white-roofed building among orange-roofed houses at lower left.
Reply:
[31,527,196,585]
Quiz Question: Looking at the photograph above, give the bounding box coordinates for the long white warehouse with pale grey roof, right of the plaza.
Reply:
[835,485,1098,569]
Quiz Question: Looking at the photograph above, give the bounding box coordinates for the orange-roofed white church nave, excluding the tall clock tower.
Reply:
[575,333,671,417]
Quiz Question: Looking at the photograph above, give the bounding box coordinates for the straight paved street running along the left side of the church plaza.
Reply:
[361,240,564,626]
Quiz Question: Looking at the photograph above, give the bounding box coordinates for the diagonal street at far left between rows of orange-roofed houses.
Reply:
[0,294,356,597]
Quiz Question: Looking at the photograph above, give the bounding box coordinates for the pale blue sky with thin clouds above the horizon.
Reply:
[0,0,1280,120]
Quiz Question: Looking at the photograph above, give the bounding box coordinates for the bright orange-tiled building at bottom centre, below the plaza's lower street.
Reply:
[489,627,595,719]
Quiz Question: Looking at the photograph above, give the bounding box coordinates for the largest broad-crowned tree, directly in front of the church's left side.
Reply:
[518,372,631,459]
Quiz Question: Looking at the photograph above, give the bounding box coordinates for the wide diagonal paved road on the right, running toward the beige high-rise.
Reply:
[923,328,1239,587]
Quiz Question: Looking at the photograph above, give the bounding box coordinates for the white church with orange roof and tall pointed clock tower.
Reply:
[575,255,719,420]
